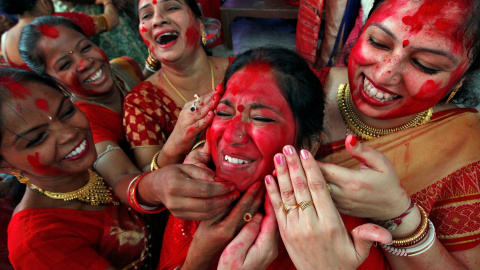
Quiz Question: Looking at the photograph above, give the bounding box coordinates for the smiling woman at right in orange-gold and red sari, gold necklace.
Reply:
[317,0,480,269]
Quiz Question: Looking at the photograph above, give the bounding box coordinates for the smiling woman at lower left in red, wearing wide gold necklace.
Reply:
[0,69,149,269]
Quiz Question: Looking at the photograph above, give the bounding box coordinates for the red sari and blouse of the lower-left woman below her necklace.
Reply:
[8,202,148,270]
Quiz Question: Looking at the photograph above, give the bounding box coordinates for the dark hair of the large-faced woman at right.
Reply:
[368,0,480,107]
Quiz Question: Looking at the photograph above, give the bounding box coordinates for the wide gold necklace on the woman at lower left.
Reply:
[12,170,119,205]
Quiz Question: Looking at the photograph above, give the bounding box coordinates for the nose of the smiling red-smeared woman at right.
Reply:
[373,55,403,85]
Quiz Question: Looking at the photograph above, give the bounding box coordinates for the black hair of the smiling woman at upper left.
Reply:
[18,16,84,76]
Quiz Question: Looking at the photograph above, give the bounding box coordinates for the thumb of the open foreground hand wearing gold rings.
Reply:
[351,223,392,262]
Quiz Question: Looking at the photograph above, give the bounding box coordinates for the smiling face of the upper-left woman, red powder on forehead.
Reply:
[37,25,114,99]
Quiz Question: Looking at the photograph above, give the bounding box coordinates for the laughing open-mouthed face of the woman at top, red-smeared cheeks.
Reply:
[138,0,203,62]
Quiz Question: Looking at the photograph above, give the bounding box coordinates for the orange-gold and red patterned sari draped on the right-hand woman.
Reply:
[322,109,480,251]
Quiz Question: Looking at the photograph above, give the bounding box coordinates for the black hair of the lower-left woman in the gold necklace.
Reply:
[0,68,63,201]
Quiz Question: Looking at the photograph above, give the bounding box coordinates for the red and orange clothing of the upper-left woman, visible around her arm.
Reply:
[75,56,143,145]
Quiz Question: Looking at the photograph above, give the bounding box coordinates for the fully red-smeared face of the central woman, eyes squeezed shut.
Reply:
[207,64,295,192]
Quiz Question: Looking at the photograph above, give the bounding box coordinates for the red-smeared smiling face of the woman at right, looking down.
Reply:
[348,0,470,119]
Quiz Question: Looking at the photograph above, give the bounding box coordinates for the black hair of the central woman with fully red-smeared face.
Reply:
[225,47,325,147]
